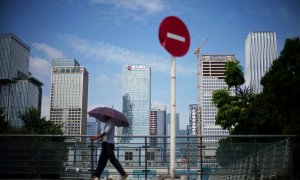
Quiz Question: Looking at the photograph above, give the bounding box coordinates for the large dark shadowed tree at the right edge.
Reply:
[261,37,300,135]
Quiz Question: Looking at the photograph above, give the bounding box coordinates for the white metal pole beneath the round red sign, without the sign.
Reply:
[170,56,176,179]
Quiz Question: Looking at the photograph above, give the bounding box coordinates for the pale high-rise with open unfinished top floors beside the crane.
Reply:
[201,55,235,167]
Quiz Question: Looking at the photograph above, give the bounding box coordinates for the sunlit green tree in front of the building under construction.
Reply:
[212,60,255,134]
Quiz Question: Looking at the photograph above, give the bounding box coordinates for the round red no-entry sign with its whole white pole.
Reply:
[158,16,190,179]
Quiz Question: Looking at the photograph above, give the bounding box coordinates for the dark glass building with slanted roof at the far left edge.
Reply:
[0,33,43,127]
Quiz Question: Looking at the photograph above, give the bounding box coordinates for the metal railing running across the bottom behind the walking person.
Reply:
[0,135,295,180]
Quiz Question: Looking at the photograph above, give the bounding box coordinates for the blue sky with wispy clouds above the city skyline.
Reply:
[0,0,300,129]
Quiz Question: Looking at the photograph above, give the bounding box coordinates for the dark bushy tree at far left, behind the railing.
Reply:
[0,108,68,179]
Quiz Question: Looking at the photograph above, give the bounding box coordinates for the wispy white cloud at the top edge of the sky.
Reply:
[90,0,164,14]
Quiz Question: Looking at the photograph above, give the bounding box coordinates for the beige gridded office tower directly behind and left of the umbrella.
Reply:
[50,59,88,139]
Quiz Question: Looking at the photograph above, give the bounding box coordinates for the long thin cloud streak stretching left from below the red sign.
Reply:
[64,35,194,75]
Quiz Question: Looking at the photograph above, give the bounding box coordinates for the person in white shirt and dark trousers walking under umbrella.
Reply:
[90,115,128,180]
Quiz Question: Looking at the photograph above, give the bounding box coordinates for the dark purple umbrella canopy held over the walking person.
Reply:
[88,107,129,127]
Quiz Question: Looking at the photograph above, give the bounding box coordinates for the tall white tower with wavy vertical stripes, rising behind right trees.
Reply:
[245,32,277,93]
